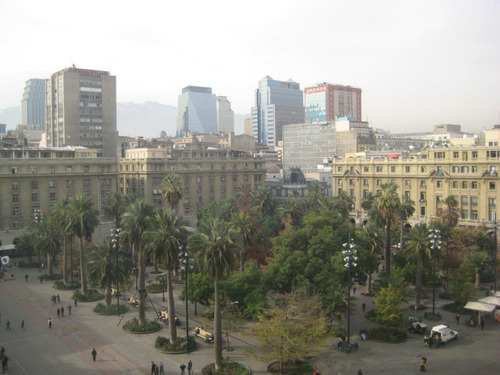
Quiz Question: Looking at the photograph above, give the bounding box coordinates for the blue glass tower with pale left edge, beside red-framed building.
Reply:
[252,76,304,146]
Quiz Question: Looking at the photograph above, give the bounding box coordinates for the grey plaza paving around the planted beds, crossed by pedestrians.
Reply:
[0,268,500,375]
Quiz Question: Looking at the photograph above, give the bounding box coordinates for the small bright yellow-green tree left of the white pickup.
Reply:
[375,284,404,327]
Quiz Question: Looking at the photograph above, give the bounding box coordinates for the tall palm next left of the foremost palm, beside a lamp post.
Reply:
[144,209,186,343]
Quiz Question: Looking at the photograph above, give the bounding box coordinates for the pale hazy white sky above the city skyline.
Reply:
[0,0,500,131]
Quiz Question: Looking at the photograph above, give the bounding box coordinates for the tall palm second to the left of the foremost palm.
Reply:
[123,199,154,325]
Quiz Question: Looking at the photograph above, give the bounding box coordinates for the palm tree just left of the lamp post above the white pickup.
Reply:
[403,224,432,305]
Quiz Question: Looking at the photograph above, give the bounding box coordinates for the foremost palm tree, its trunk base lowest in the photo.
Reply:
[188,218,236,371]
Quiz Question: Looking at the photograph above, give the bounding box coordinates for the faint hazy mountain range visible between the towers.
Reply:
[0,102,250,138]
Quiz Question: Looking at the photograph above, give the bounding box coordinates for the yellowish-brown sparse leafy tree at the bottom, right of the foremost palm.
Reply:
[253,292,327,373]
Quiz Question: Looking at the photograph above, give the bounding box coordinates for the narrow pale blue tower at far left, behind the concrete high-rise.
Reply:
[21,78,45,130]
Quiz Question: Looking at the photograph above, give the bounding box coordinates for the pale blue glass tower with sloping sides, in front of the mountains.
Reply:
[177,86,218,136]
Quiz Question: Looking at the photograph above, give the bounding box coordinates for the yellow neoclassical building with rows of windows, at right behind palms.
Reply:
[332,145,500,226]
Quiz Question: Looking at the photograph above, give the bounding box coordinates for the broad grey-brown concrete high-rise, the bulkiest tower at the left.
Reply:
[46,66,118,156]
